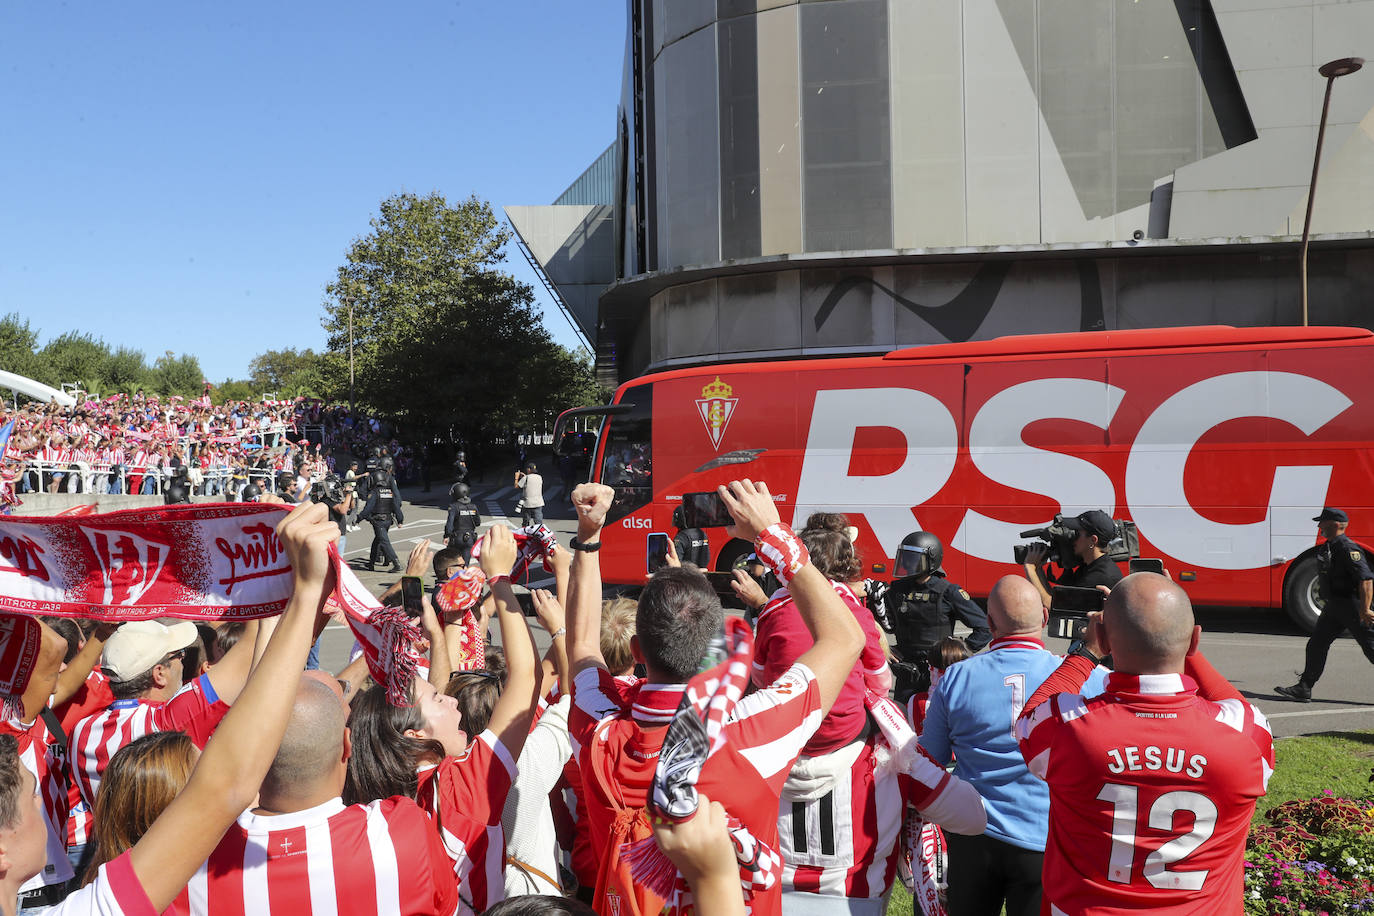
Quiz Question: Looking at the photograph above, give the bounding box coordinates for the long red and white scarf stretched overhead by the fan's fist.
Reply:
[0,503,423,706]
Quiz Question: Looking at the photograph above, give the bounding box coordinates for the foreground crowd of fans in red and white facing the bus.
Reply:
[0,477,1274,916]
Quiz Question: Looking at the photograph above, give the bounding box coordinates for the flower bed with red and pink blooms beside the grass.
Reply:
[1245,792,1374,916]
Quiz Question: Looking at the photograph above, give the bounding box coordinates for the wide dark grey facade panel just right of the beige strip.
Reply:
[801,0,892,251]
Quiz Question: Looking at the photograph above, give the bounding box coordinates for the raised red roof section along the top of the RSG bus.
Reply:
[882,324,1374,360]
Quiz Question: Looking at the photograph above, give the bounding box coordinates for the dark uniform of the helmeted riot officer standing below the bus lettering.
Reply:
[882,570,992,703]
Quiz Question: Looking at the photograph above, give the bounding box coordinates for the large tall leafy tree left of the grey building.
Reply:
[324,194,599,442]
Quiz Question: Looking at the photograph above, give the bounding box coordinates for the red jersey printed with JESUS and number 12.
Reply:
[1020,674,1274,916]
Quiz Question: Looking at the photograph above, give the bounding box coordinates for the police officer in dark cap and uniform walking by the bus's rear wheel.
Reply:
[1274,507,1374,703]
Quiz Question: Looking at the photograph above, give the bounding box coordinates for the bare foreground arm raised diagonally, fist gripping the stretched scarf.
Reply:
[131,503,339,912]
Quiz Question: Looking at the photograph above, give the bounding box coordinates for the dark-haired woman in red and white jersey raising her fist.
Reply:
[346,525,541,913]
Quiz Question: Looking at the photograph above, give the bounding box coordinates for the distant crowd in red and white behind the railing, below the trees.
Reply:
[0,390,423,503]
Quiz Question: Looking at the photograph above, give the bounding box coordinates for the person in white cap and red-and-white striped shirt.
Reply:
[69,621,258,809]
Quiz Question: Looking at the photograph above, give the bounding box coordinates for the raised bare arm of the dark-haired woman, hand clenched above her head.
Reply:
[481,525,540,758]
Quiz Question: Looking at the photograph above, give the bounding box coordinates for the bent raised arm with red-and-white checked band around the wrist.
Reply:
[719,479,864,715]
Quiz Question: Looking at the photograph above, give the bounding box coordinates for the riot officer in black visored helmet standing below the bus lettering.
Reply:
[878,531,992,703]
